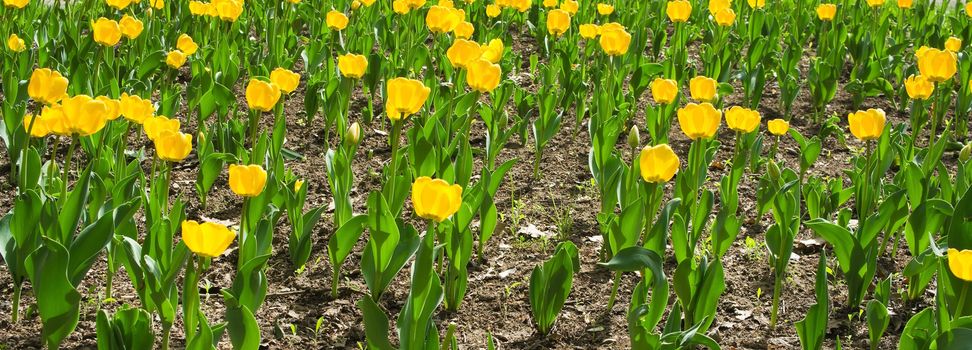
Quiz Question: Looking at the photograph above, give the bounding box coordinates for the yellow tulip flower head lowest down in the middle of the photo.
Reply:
[412,176,462,222]
